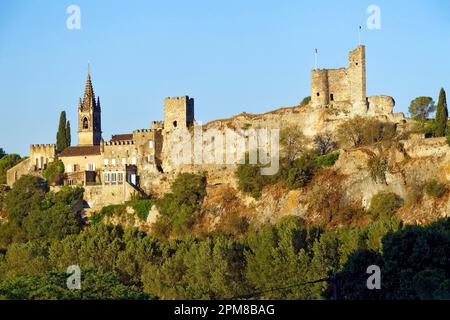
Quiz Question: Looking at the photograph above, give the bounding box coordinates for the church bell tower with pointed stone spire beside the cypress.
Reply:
[78,67,102,146]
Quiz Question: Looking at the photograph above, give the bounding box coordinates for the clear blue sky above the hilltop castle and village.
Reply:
[0,0,450,155]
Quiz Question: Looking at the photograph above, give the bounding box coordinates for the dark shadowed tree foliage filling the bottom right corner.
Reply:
[341,219,450,300]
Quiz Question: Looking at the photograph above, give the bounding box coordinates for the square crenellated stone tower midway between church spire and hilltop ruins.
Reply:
[164,96,194,132]
